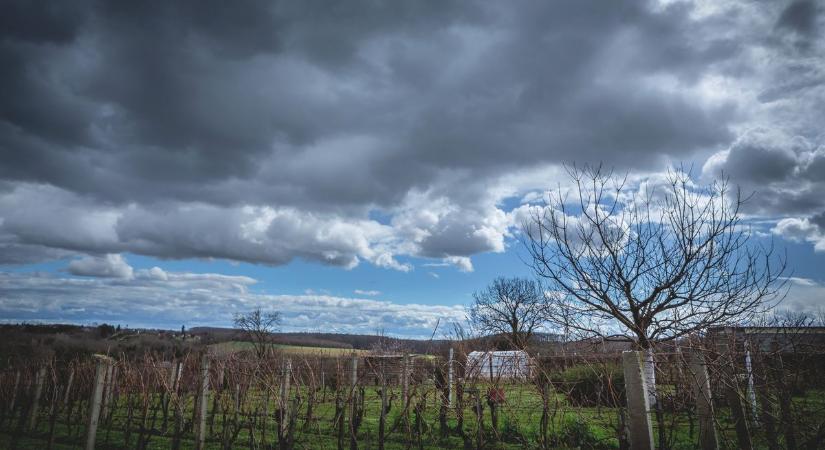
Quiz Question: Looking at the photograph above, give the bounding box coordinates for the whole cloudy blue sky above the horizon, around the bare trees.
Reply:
[0,0,825,337]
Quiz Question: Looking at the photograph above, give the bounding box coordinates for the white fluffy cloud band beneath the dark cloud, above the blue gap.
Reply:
[0,178,514,270]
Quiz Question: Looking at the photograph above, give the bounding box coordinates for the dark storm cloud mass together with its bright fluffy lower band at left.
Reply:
[0,0,819,272]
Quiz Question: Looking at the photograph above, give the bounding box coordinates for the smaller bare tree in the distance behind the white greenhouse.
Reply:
[470,277,546,350]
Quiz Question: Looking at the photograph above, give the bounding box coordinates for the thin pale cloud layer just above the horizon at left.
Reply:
[0,267,464,338]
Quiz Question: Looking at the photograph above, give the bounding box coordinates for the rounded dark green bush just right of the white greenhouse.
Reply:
[550,364,624,407]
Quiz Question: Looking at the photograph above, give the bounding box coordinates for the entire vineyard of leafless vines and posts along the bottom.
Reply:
[0,332,825,449]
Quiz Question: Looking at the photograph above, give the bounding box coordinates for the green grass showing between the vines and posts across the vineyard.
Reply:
[0,384,825,449]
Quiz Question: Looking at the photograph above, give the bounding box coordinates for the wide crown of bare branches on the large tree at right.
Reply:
[524,167,785,348]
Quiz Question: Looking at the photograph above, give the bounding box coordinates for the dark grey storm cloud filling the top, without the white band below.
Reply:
[3,1,729,204]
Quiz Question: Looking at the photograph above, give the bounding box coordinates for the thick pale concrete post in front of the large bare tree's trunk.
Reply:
[622,351,654,450]
